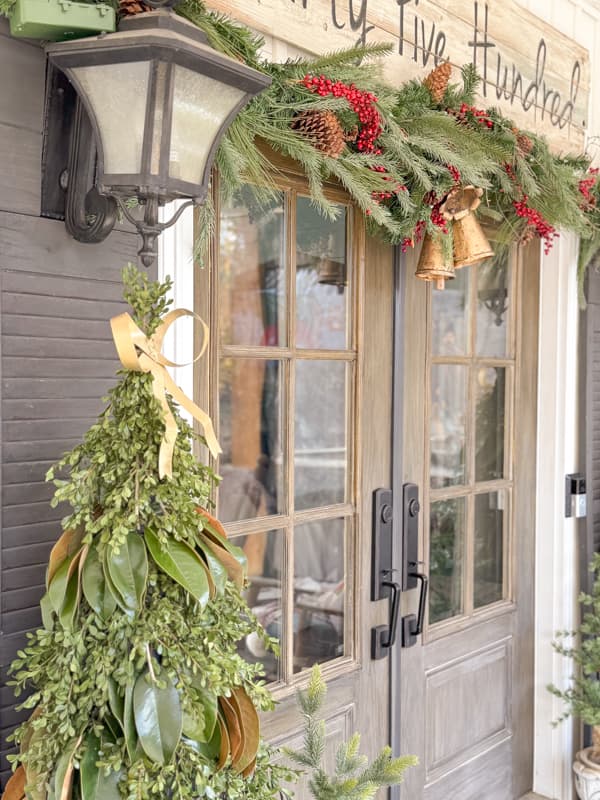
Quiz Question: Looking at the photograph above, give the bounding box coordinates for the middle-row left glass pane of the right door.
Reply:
[429,364,467,489]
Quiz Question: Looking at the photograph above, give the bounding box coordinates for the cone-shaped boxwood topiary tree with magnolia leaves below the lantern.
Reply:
[0,266,289,800]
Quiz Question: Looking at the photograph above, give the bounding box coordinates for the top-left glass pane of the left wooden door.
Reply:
[219,189,286,346]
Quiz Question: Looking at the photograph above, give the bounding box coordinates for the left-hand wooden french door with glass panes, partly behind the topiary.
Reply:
[196,174,393,780]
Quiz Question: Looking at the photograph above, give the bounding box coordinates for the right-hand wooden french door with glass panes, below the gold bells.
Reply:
[393,244,538,800]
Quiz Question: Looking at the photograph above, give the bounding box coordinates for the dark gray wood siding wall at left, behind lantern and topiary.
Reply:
[0,26,148,782]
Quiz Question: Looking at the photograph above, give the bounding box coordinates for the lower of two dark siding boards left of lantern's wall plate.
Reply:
[0,123,42,216]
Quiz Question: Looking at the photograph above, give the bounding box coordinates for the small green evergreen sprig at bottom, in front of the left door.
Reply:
[286,664,417,800]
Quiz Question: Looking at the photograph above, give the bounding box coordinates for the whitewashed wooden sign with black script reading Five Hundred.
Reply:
[208,0,590,151]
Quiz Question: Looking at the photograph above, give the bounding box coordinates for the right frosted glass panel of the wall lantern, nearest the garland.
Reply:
[169,65,245,185]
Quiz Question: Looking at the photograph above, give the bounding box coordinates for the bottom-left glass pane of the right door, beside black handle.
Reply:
[429,497,466,624]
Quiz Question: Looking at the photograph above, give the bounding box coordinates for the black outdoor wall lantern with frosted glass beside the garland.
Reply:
[45,9,270,267]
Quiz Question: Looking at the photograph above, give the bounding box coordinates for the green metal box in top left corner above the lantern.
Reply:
[10,0,116,42]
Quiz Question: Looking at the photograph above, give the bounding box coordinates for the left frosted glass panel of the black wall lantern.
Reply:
[70,61,150,175]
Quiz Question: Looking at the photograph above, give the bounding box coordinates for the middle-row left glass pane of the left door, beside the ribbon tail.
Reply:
[219,358,284,522]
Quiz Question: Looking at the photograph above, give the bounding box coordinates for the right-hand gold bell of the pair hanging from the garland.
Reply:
[440,186,494,269]
